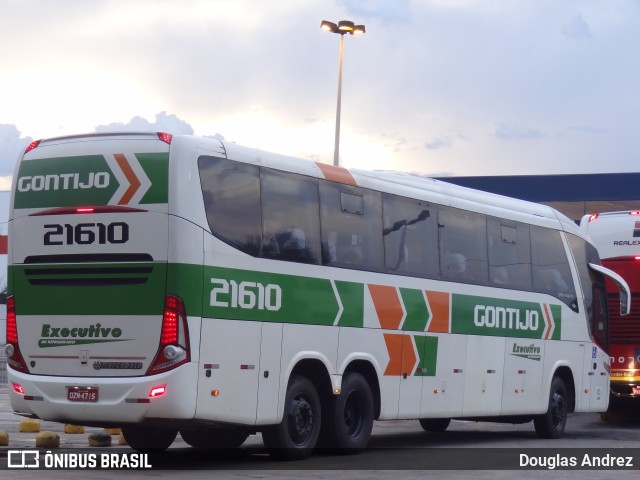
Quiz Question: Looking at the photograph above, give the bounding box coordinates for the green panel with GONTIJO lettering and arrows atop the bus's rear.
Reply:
[16,152,169,208]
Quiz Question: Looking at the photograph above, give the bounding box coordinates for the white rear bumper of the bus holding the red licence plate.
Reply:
[8,363,198,426]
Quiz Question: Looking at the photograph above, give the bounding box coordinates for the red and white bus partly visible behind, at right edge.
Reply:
[580,210,640,409]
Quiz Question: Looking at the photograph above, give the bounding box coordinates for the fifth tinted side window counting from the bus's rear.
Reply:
[438,207,489,285]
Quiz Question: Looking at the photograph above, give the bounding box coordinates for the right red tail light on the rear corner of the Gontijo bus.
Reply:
[147,295,191,375]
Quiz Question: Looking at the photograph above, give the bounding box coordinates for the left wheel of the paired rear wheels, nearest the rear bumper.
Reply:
[262,375,322,460]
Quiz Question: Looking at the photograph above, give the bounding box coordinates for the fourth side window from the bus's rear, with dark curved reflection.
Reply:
[382,194,439,277]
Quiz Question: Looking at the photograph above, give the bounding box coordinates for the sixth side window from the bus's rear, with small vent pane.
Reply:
[487,217,531,290]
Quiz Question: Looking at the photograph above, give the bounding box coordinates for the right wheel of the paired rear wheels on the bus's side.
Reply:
[322,372,374,454]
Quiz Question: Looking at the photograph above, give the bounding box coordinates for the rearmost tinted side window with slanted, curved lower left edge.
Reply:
[198,156,262,256]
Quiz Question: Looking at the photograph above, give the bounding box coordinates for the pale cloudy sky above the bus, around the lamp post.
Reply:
[0,0,640,189]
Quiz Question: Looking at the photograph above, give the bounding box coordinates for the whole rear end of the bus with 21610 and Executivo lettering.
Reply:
[7,134,195,424]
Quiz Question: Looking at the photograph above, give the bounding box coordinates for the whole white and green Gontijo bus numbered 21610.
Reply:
[6,133,628,458]
